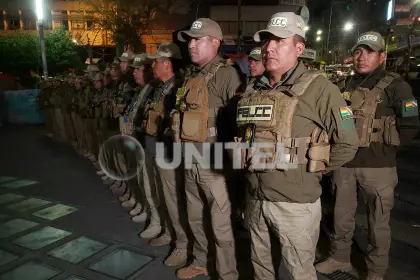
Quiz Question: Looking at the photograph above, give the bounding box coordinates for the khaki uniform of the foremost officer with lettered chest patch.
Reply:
[237,62,357,280]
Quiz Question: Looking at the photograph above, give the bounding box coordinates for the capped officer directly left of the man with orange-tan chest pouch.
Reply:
[145,43,188,266]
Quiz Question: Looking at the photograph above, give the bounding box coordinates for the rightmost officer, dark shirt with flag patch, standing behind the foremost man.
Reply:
[316,32,419,280]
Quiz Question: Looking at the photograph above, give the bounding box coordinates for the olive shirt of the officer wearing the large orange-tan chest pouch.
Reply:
[183,55,245,163]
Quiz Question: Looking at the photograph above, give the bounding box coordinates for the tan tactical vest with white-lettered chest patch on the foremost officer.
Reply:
[235,70,330,172]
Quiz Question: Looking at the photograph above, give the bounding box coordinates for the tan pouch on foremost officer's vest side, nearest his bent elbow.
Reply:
[308,127,330,173]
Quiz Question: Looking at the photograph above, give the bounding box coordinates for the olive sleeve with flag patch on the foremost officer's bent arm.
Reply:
[317,78,358,172]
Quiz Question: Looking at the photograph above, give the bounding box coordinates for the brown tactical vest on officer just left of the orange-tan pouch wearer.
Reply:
[144,83,174,137]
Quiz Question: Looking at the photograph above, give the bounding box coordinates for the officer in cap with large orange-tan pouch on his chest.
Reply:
[172,18,243,280]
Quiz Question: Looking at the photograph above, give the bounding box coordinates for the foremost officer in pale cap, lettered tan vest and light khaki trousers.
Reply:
[236,12,357,280]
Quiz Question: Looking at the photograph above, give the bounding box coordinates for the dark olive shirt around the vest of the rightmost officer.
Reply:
[342,66,419,168]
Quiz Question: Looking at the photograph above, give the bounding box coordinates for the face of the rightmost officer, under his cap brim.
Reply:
[353,45,385,74]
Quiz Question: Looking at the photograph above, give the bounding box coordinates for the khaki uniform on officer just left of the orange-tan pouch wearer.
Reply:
[144,76,188,249]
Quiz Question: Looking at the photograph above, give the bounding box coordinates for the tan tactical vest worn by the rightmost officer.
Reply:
[350,72,400,147]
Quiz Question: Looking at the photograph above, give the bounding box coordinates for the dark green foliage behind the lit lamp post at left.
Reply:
[0,28,82,77]
